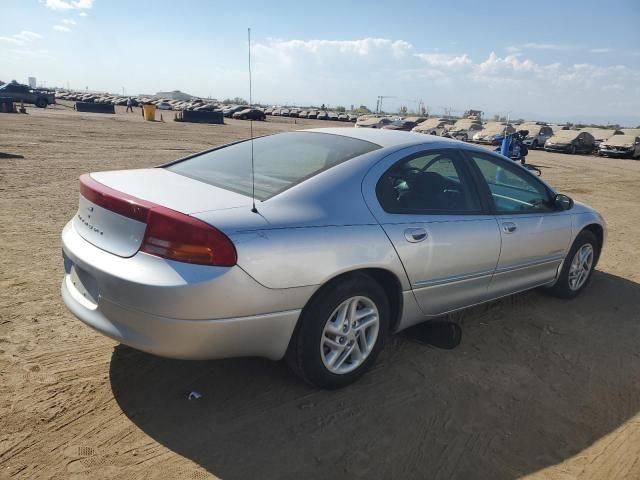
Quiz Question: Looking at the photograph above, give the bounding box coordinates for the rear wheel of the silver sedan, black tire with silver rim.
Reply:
[286,274,389,389]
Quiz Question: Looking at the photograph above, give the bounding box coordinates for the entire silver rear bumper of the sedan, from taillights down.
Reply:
[61,222,313,360]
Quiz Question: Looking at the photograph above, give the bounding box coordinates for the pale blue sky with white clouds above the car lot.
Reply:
[0,0,640,126]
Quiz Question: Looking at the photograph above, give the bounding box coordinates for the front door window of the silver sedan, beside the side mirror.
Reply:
[470,152,554,213]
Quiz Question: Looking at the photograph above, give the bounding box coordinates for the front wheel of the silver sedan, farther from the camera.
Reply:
[549,230,600,298]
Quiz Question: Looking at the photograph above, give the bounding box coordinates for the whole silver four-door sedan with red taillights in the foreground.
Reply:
[62,128,606,388]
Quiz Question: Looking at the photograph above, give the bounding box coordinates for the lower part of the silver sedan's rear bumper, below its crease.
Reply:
[62,275,300,360]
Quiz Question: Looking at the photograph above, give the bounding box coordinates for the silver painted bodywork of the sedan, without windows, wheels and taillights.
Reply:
[62,128,606,359]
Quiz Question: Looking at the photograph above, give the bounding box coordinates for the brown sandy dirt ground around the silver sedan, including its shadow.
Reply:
[0,107,640,480]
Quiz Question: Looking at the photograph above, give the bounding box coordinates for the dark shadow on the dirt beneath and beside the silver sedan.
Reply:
[110,272,640,479]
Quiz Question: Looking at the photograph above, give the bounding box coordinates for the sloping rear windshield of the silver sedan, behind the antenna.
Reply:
[166,132,380,200]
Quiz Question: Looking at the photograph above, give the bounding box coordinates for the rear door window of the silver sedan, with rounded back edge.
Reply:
[376,150,481,214]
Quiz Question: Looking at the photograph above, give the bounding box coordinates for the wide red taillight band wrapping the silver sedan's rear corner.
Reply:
[80,175,237,267]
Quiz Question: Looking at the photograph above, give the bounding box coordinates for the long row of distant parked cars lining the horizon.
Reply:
[48,87,640,158]
